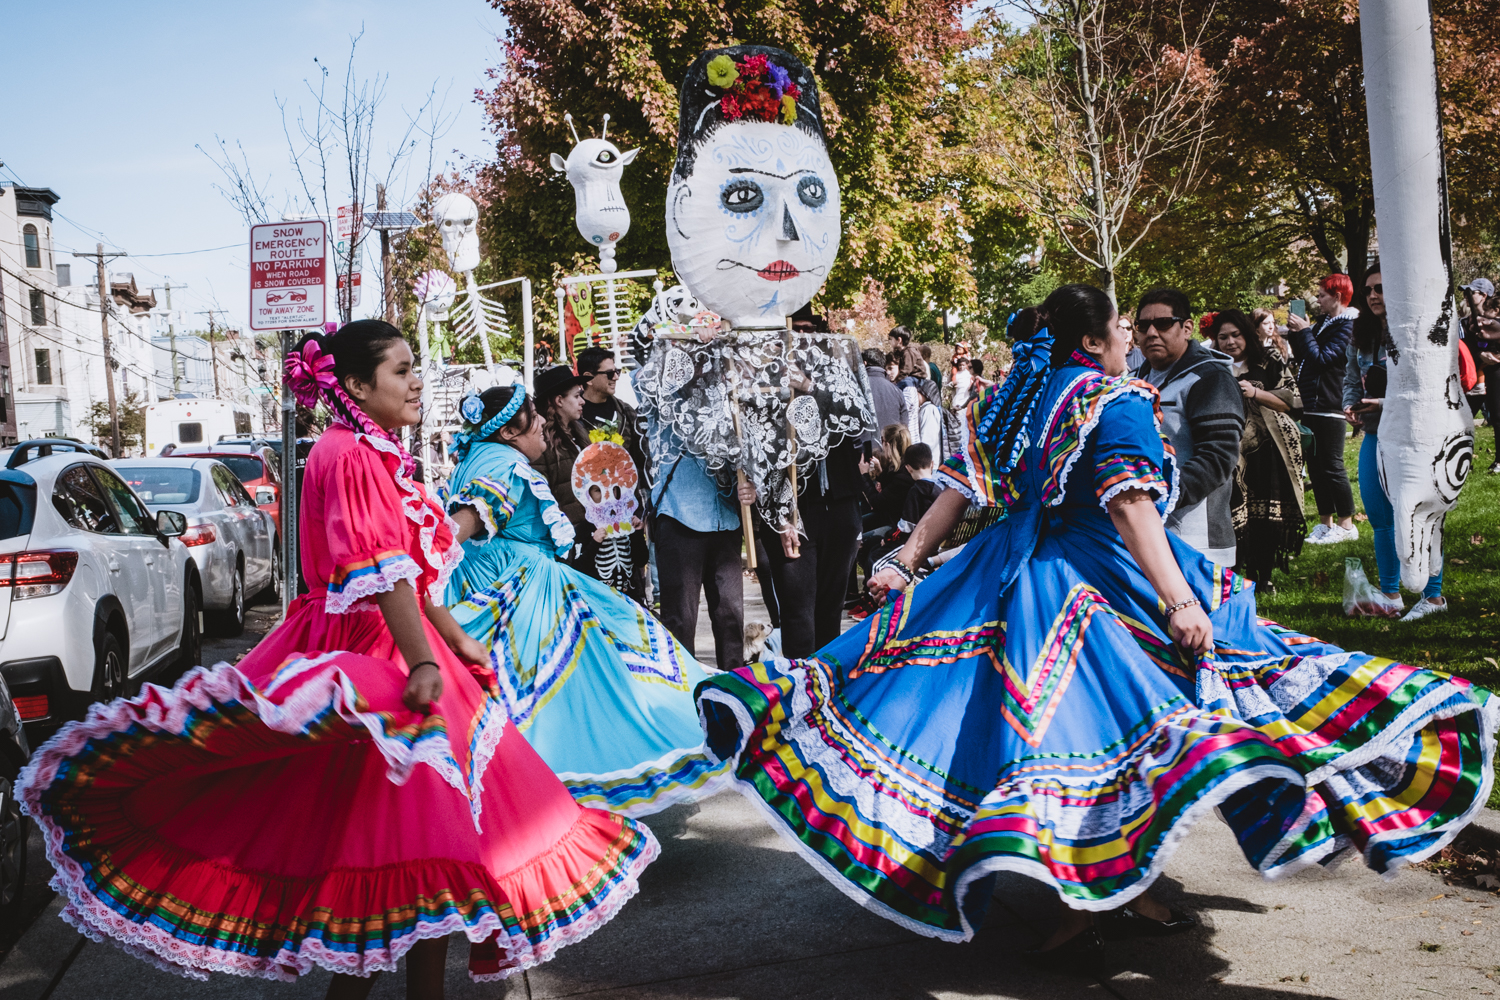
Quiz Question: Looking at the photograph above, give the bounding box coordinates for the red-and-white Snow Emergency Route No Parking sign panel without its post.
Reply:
[251,220,329,330]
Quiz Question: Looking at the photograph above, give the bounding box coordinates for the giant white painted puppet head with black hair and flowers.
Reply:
[666,45,840,328]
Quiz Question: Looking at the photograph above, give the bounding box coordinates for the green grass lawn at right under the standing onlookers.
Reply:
[1256,427,1500,690]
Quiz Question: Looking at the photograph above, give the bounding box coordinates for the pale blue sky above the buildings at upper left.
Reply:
[0,0,504,325]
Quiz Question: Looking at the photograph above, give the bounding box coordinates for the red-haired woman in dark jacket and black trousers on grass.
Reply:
[1287,274,1359,546]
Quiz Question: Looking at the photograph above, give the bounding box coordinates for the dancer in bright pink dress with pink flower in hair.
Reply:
[20,319,657,997]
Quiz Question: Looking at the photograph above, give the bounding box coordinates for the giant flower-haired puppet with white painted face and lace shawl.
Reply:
[638,45,878,539]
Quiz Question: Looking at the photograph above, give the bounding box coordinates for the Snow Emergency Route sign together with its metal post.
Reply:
[251,220,329,616]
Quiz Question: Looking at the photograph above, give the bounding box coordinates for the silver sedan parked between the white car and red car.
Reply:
[113,457,281,636]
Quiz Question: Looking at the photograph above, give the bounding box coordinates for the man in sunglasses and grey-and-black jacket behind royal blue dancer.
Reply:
[1136,288,1245,567]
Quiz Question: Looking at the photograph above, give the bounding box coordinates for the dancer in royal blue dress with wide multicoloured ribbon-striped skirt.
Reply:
[698,285,1500,964]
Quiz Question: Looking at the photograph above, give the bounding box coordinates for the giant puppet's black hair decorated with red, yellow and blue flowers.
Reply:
[674,45,828,177]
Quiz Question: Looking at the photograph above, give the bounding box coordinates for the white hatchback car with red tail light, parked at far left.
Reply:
[0,453,203,732]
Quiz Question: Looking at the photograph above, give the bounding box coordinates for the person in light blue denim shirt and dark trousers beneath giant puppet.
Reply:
[647,411,756,670]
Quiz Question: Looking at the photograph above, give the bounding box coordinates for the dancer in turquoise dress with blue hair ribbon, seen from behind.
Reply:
[447,384,726,816]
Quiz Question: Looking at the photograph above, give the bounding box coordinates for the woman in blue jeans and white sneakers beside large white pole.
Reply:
[1344,261,1448,622]
